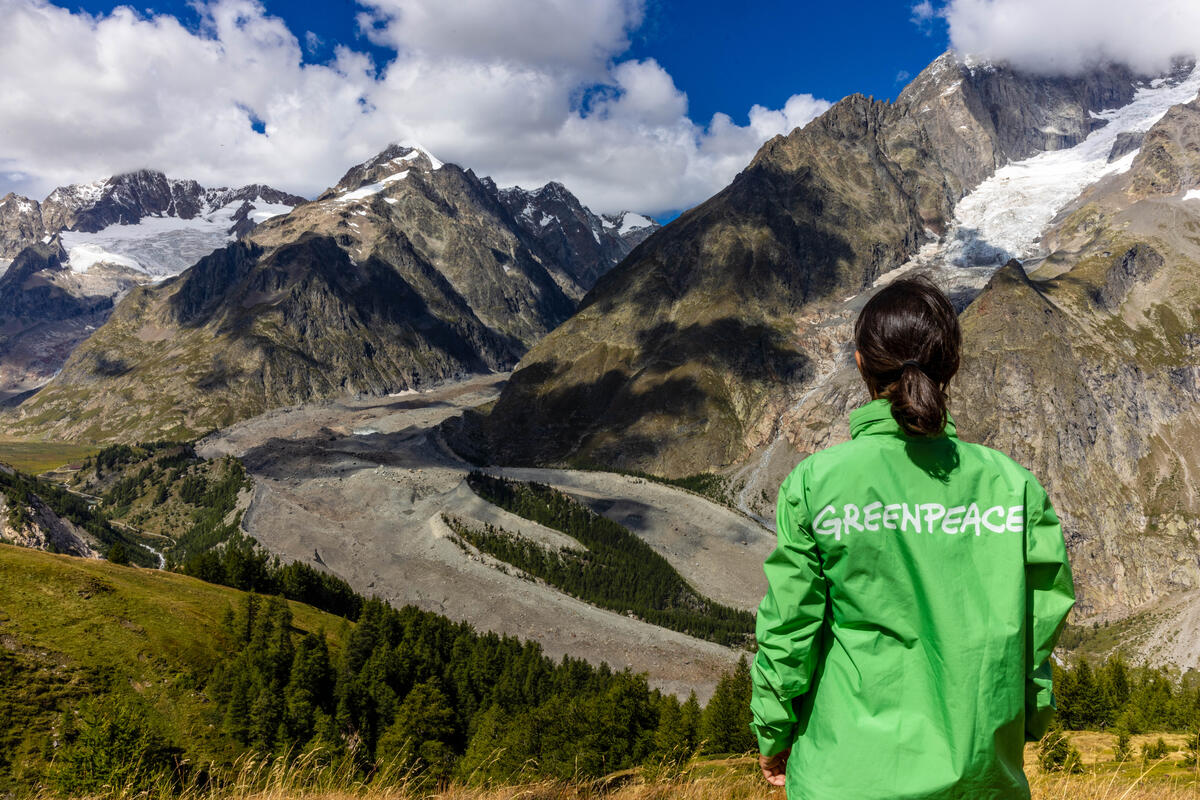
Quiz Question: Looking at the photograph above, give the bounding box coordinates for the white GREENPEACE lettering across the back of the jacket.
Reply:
[812,501,1025,541]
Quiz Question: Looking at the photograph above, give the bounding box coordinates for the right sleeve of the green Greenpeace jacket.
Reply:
[1025,481,1075,741]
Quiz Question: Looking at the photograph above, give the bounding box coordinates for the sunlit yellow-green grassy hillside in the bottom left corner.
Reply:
[0,545,347,794]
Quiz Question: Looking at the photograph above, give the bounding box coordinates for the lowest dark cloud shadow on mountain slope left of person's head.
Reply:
[443,318,812,467]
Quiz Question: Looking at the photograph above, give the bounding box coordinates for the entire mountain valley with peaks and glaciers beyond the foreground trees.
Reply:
[0,45,1200,786]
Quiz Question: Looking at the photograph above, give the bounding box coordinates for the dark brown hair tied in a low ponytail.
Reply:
[854,276,962,437]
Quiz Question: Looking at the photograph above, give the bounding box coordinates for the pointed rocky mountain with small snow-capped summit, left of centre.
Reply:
[6,146,619,439]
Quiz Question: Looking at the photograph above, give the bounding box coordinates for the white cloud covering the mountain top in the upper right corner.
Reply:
[945,0,1200,74]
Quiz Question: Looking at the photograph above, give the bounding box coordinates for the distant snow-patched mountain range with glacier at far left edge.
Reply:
[0,170,305,402]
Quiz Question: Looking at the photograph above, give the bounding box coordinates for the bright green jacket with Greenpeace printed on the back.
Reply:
[751,399,1075,800]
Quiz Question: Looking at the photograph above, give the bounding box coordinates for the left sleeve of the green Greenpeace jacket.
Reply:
[750,470,826,756]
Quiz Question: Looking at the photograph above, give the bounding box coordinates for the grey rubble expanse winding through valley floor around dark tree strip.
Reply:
[198,375,774,700]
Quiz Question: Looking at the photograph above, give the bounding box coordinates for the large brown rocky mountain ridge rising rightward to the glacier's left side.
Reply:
[463,54,1135,475]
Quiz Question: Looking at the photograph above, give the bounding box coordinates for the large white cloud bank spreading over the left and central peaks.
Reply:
[0,0,828,213]
